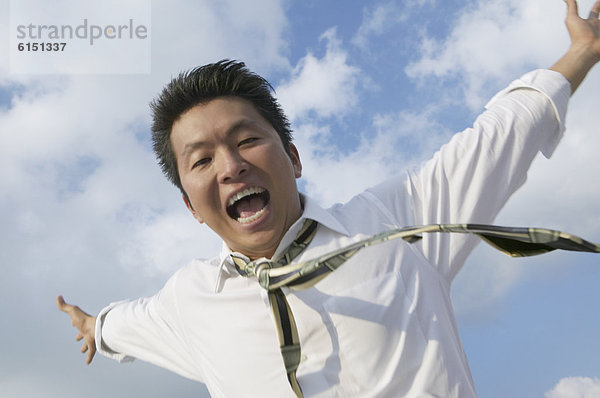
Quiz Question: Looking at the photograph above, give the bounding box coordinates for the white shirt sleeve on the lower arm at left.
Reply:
[95,273,203,381]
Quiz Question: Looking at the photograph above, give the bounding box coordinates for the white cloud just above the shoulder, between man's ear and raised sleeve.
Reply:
[296,105,449,205]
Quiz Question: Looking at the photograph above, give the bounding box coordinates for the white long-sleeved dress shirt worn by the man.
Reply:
[96,70,571,398]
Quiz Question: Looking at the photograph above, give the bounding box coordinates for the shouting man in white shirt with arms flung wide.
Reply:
[57,0,600,397]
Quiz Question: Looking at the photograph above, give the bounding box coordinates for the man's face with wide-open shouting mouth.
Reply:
[171,97,302,259]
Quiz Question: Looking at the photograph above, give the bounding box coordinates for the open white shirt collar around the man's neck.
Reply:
[215,193,348,293]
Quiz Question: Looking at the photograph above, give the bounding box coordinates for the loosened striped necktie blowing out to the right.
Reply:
[231,219,600,397]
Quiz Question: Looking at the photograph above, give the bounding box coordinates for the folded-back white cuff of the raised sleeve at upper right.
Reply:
[485,69,571,158]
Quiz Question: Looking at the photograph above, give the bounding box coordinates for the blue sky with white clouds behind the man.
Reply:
[0,0,600,398]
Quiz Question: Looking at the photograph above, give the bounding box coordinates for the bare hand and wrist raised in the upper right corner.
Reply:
[550,0,600,93]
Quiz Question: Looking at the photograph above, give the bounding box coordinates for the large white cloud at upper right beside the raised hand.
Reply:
[406,0,568,109]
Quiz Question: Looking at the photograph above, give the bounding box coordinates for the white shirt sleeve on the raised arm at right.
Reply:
[374,70,571,280]
